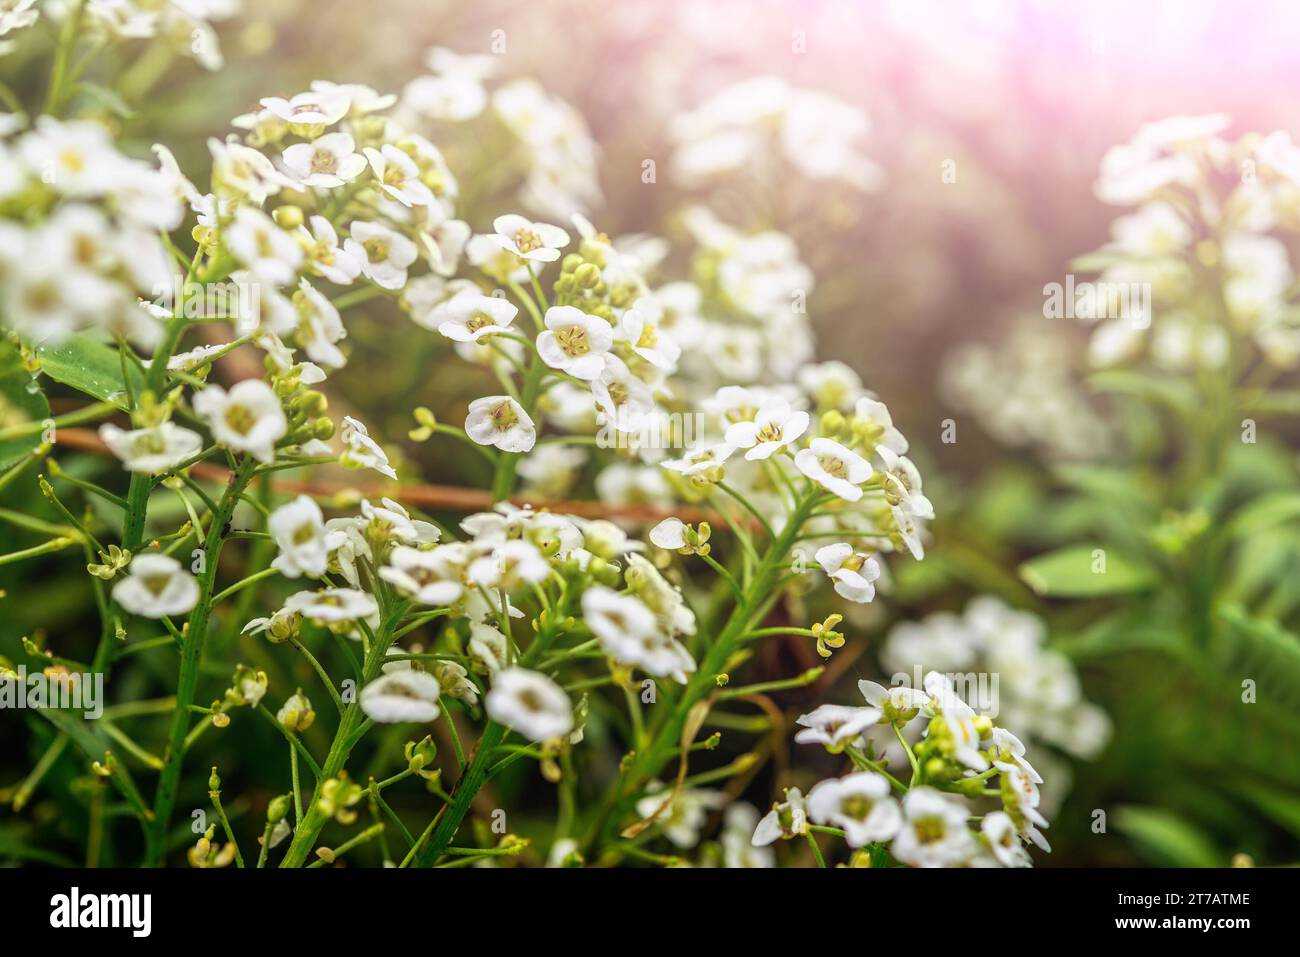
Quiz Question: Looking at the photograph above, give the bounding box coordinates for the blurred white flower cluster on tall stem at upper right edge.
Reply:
[1080,114,1300,372]
